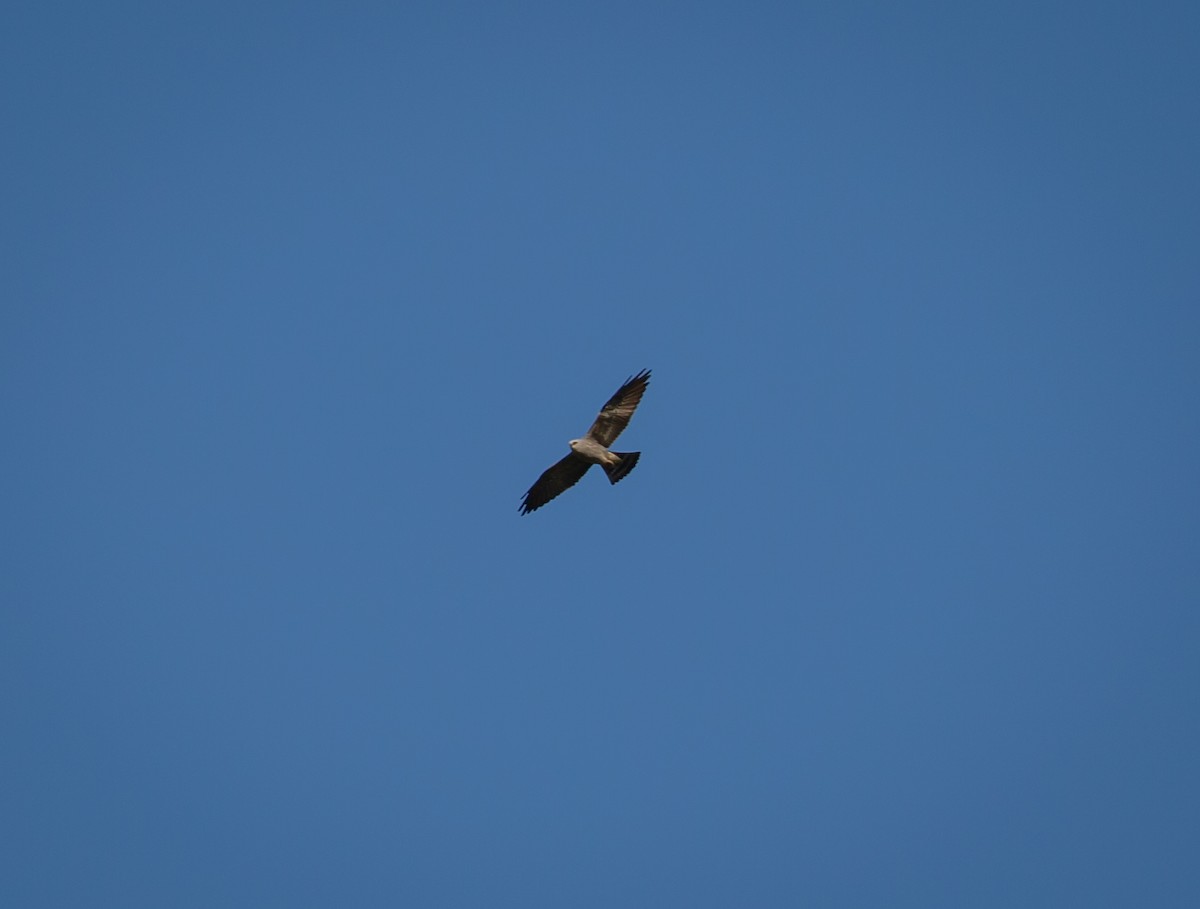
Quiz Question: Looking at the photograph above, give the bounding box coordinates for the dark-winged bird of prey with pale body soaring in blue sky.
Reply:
[521,369,650,514]
